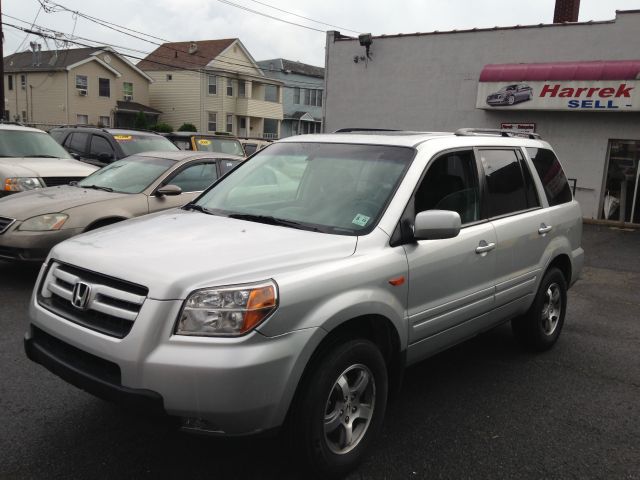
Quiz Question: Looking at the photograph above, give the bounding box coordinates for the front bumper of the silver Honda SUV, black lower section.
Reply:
[25,290,324,435]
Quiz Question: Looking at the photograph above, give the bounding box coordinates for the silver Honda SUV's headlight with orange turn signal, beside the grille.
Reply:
[176,280,278,337]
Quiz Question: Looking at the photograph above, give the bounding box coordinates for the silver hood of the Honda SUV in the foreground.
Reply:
[52,209,357,300]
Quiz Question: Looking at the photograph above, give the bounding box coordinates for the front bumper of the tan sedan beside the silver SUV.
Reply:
[0,226,82,262]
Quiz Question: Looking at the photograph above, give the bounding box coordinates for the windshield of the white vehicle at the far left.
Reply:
[0,130,71,158]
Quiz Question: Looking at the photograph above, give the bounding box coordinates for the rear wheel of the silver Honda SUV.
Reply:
[511,267,567,352]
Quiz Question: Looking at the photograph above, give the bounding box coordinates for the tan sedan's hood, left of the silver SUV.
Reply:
[0,185,129,220]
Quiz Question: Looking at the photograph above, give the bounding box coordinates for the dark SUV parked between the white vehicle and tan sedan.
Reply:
[49,126,178,167]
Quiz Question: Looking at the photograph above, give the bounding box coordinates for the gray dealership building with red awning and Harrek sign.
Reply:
[323,4,640,223]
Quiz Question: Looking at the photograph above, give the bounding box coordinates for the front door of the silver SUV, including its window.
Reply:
[404,149,497,344]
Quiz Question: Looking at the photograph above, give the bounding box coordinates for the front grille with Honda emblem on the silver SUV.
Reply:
[38,263,149,338]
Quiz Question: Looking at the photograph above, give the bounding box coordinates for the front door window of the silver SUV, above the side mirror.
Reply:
[414,150,480,225]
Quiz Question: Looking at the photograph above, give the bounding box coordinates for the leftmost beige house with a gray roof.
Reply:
[4,43,161,129]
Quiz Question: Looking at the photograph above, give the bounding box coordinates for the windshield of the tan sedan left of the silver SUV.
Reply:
[78,155,176,193]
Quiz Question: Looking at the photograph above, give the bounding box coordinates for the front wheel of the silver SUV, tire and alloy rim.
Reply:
[289,339,388,479]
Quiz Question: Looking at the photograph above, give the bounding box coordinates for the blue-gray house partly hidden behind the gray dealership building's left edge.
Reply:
[257,58,324,138]
